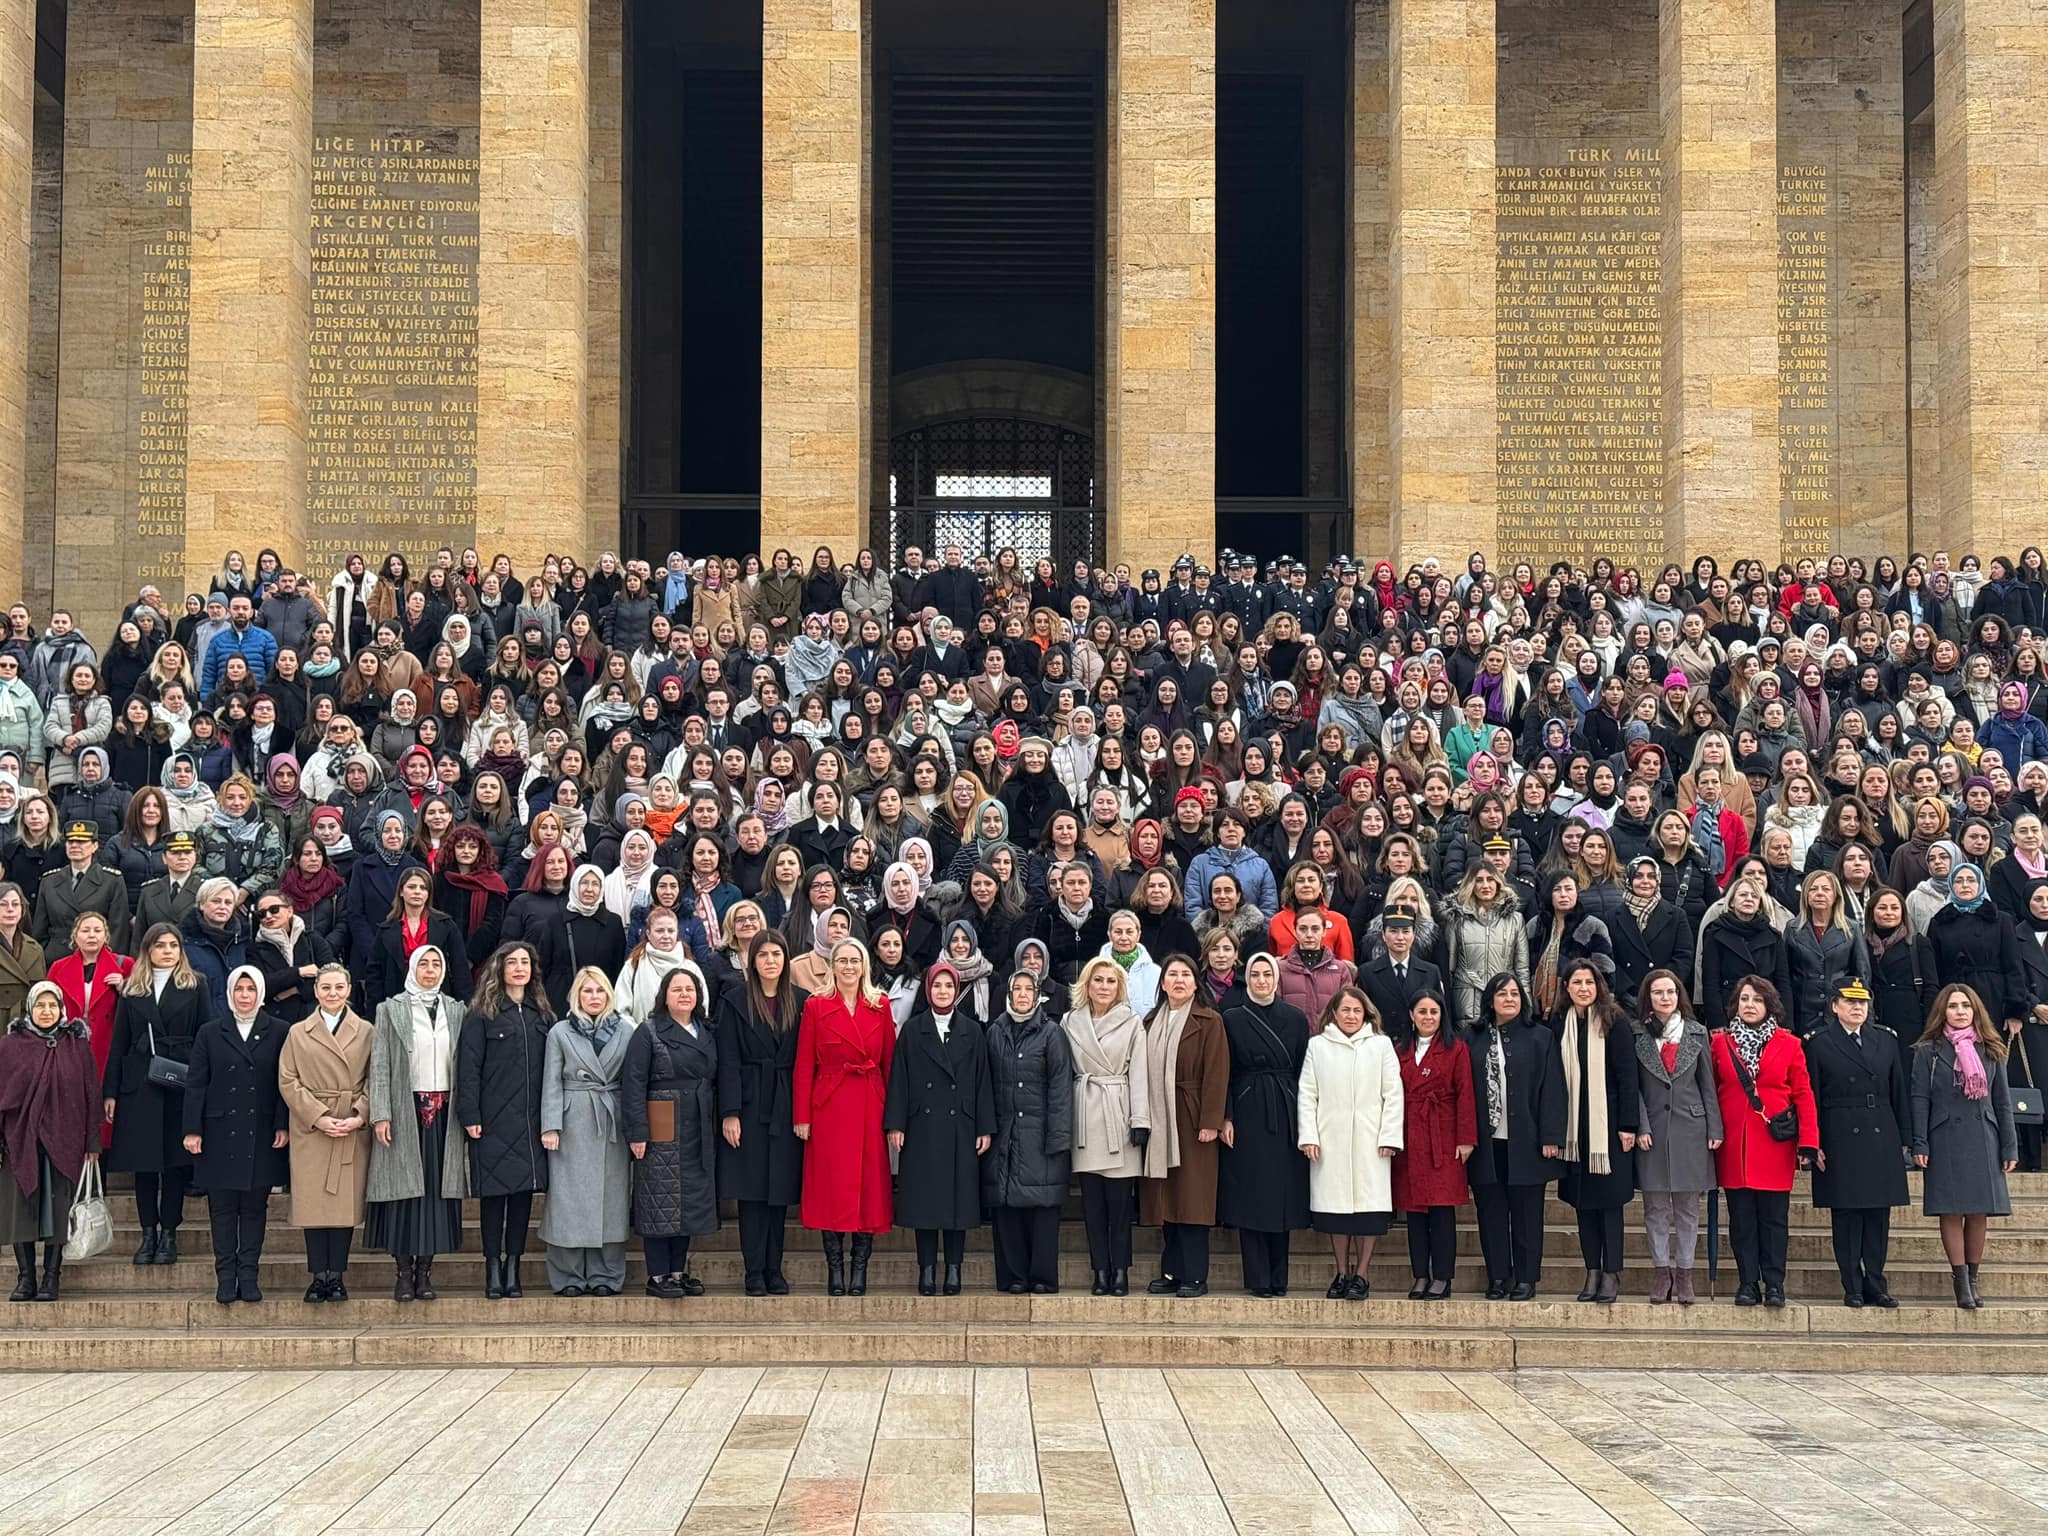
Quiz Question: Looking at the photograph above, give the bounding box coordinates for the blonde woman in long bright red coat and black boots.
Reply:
[793,938,895,1296]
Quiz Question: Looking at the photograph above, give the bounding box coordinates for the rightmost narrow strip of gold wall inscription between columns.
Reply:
[1778,164,1841,553]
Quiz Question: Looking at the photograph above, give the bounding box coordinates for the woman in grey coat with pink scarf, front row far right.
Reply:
[1913,983,2019,1311]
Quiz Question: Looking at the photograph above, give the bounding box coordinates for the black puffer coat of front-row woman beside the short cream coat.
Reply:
[981,1008,1073,1210]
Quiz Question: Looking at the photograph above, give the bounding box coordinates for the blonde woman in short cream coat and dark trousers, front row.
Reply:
[1061,954,1174,1296]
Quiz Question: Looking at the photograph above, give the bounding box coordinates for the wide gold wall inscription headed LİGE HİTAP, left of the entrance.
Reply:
[307,129,477,571]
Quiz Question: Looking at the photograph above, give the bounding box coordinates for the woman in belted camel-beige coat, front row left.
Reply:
[276,965,371,1300]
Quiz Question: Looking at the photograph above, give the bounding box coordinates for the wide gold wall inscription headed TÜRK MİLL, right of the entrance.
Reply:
[1495,145,1663,563]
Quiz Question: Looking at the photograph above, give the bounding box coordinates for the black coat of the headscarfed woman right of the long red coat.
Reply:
[883,1010,995,1231]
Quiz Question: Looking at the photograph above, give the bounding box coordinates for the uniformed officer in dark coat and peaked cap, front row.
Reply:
[1806,975,1913,1307]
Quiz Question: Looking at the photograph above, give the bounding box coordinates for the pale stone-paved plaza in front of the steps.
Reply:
[0,1366,2048,1536]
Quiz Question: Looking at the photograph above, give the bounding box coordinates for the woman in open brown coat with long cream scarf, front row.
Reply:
[1139,954,1231,1296]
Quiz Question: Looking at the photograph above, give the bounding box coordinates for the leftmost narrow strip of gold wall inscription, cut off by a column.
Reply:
[131,150,193,600]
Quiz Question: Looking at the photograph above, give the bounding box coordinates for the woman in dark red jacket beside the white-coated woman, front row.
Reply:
[1395,991,1479,1300]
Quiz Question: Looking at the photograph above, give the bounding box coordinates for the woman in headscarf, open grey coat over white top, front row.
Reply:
[362,944,469,1300]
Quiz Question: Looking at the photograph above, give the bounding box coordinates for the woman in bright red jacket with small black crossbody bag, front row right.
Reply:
[1714,977,1821,1307]
